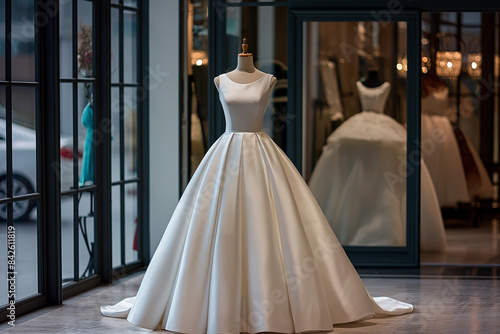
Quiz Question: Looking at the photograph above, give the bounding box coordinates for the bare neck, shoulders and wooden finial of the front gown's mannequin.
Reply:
[214,37,277,87]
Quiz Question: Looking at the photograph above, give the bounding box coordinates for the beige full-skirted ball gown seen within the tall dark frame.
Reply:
[309,81,446,251]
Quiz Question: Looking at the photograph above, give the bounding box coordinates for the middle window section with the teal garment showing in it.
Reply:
[59,0,96,284]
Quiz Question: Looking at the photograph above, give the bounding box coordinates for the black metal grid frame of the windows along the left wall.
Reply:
[0,0,150,321]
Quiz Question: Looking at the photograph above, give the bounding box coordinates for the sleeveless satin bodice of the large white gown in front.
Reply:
[217,74,273,132]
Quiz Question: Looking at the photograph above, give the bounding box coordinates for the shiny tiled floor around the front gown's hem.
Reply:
[0,273,500,334]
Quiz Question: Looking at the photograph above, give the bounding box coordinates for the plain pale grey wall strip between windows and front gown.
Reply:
[149,0,179,255]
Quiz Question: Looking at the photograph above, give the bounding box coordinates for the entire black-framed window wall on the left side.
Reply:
[0,0,149,319]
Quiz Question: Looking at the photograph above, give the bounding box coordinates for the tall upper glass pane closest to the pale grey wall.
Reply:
[123,10,139,83]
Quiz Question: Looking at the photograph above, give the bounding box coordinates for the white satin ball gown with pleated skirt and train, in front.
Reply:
[101,74,413,333]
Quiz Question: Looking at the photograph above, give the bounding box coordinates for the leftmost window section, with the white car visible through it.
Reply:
[0,0,41,305]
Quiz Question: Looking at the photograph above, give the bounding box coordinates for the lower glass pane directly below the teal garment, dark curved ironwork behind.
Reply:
[78,191,95,278]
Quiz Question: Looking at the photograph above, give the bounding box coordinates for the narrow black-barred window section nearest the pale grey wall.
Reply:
[111,1,141,268]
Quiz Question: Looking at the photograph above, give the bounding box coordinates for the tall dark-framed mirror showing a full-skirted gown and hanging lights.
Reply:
[294,11,422,266]
